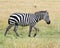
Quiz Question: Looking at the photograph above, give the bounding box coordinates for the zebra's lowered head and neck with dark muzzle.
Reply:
[35,11,51,24]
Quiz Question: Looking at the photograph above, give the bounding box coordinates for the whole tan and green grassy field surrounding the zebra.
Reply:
[0,0,60,48]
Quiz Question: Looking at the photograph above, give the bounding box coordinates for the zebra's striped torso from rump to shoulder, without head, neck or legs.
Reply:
[8,13,37,26]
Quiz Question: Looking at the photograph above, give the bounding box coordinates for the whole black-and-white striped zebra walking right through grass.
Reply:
[4,11,51,37]
